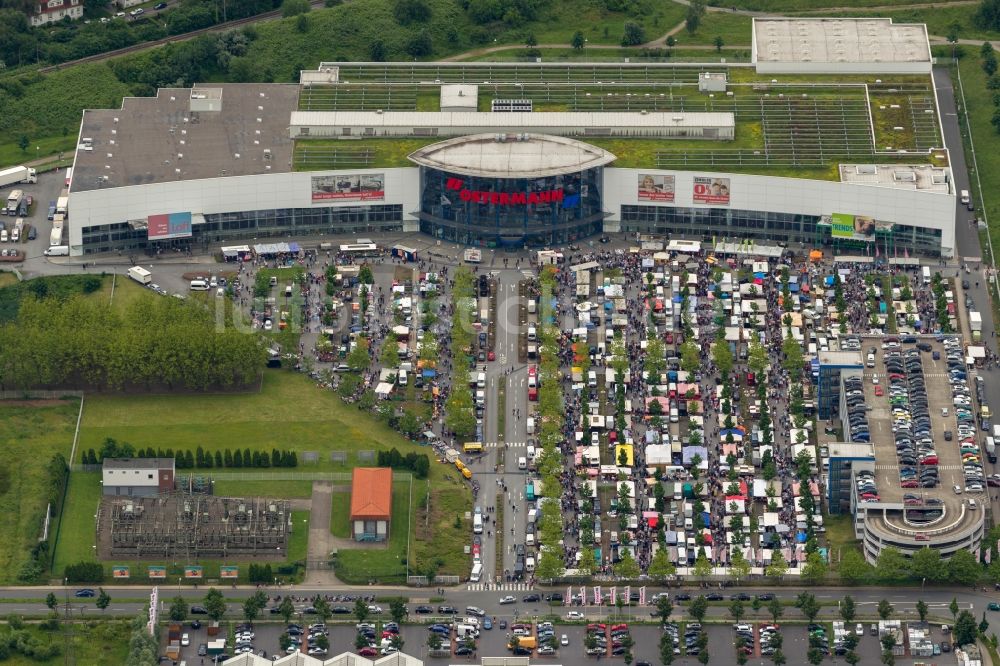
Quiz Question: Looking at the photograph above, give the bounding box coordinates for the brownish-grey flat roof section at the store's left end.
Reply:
[72,83,299,192]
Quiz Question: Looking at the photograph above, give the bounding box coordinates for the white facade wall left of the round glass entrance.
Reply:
[69,167,420,254]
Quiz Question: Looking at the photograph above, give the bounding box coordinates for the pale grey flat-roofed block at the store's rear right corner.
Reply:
[753,18,931,63]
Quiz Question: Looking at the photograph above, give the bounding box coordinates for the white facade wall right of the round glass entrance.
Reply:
[604,168,955,256]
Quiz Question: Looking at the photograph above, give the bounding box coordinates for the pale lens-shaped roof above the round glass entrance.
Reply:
[410,134,615,177]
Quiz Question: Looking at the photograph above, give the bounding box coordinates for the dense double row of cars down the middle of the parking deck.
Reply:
[885,343,940,488]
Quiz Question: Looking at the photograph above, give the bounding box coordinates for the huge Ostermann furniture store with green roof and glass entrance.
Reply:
[67,19,956,257]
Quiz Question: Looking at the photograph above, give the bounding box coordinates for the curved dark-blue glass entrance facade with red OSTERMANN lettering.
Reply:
[419,167,605,247]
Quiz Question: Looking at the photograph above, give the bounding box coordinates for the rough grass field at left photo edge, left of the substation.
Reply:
[0,400,79,584]
